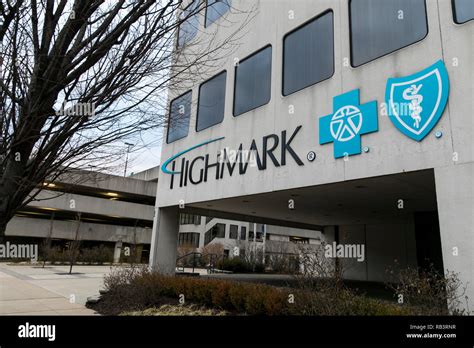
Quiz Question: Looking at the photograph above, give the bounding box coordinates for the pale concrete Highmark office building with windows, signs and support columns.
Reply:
[151,0,474,308]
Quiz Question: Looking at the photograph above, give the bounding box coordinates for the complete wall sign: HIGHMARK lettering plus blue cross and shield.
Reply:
[161,60,449,189]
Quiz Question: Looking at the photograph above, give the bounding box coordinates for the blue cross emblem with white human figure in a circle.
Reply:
[319,89,379,158]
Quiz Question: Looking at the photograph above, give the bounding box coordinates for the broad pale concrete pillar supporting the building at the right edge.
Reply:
[435,163,474,310]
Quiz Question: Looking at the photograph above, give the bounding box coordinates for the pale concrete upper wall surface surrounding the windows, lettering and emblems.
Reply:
[158,0,474,206]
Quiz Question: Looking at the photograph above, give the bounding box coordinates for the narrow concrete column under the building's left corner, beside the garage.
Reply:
[149,206,179,275]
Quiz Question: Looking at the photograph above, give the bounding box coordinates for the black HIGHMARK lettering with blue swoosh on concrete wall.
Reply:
[161,126,304,189]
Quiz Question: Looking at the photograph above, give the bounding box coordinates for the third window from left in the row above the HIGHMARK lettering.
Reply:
[234,46,272,116]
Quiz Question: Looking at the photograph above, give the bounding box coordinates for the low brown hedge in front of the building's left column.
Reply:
[96,268,288,315]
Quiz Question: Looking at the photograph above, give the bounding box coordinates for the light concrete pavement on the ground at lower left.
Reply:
[0,263,117,315]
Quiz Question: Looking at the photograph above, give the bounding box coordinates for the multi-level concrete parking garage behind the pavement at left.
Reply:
[6,171,156,262]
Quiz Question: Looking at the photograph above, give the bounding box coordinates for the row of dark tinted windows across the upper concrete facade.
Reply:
[167,0,474,143]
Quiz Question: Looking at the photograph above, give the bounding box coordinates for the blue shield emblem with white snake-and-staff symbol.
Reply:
[385,60,449,141]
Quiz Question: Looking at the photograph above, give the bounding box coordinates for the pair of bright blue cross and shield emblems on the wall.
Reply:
[319,60,449,158]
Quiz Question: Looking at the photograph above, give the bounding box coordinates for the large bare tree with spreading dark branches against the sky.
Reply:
[0,0,251,238]
